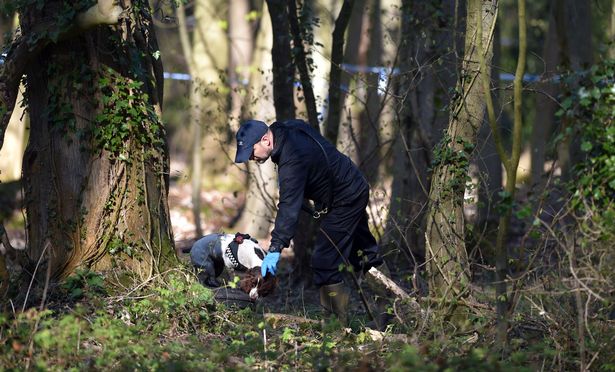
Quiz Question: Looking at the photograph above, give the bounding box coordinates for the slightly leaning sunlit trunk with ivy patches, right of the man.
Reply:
[425,0,497,307]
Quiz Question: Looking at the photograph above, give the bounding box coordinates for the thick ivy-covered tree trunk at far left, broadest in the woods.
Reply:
[20,0,176,279]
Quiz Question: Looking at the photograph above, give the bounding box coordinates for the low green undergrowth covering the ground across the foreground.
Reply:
[0,270,576,371]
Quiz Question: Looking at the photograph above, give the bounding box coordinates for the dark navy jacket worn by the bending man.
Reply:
[269,120,369,251]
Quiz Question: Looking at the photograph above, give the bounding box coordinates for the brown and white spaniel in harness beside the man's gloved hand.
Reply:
[190,233,277,300]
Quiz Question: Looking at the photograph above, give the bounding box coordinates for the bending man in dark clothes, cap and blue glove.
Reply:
[235,119,385,323]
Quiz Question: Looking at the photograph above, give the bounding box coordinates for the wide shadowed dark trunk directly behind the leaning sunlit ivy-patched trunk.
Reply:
[385,1,455,269]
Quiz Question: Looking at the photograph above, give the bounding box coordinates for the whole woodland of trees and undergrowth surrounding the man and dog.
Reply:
[0,0,615,371]
